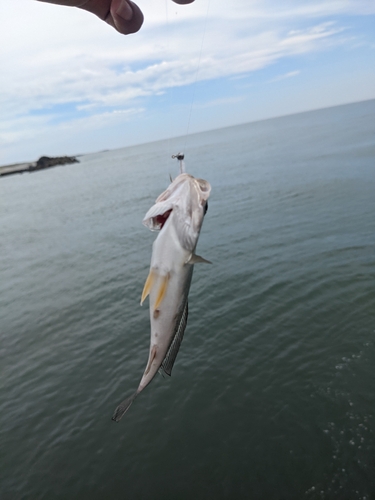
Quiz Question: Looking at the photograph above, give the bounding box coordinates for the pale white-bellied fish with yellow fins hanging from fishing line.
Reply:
[112,169,211,422]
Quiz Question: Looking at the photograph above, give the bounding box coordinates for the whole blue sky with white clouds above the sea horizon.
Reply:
[0,0,375,165]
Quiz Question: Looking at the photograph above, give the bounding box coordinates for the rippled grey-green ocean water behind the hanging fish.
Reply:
[0,101,375,500]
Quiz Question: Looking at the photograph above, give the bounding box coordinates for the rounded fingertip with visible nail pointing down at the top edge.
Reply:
[105,0,143,35]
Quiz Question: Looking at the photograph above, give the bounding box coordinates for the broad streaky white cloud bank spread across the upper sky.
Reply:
[0,0,375,162]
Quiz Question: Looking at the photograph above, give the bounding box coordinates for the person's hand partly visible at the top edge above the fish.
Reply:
[39,0,194,35]
